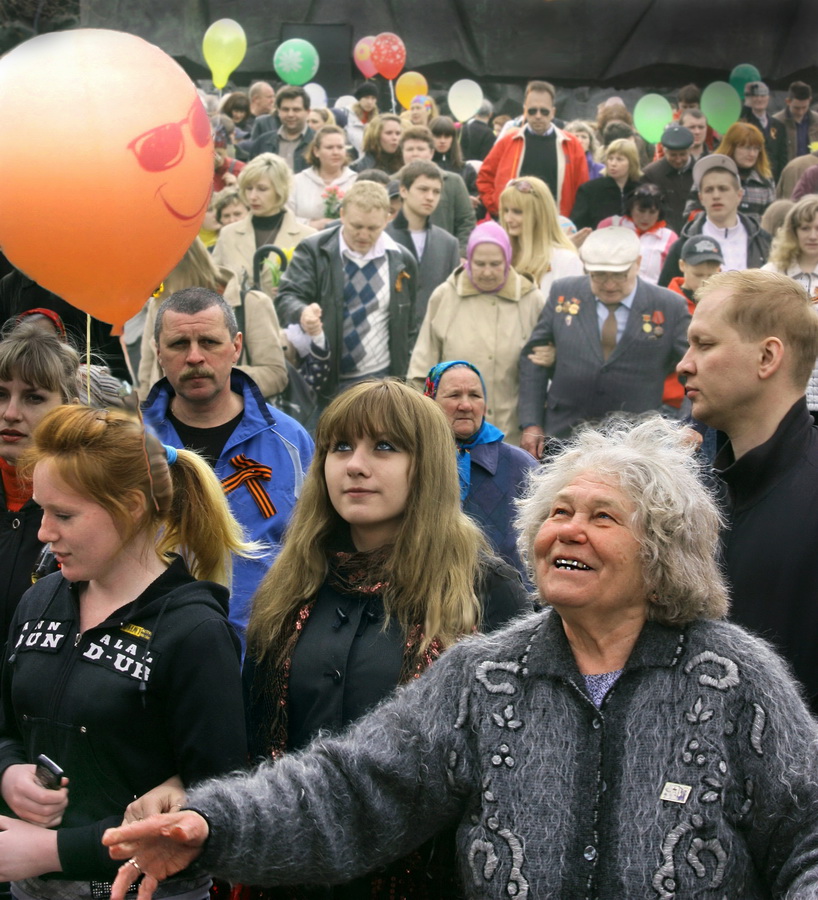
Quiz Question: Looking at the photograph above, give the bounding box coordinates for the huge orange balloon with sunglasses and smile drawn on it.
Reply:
[0,29,213,325]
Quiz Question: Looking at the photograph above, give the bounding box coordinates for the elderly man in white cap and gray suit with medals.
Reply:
[518,226,690,459]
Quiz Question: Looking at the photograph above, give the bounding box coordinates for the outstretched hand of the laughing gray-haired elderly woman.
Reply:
[102,810,208,900]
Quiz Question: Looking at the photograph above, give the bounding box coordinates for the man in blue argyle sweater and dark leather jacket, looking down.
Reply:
[275,181,417,401]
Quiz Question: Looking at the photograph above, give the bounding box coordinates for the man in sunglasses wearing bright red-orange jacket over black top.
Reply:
[477,81,588,216]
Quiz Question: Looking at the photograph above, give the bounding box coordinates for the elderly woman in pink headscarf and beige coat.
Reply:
[408,222,545,444]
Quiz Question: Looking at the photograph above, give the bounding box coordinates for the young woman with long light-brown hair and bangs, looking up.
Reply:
[237,380,532,898]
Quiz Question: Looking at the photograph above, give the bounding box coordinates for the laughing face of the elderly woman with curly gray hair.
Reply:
[534,472,647,617]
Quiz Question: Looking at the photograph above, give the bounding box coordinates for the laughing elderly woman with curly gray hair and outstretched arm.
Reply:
[104,419,818,900]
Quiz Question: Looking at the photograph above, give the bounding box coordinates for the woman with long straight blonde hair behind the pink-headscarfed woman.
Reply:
[500,177,585,297]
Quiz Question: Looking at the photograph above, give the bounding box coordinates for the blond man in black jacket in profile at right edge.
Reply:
[677,270,818,713]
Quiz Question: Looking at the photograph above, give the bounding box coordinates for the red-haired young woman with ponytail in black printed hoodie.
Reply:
[0,405,255,900]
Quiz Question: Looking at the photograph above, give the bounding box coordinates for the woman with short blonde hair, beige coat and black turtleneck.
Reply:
[213,153,315,297]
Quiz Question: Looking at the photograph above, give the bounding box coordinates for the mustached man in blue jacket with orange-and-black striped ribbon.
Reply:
[143,287,313,644]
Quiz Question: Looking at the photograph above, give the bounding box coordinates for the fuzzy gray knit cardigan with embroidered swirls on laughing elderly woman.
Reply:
[189,612,818,900]
